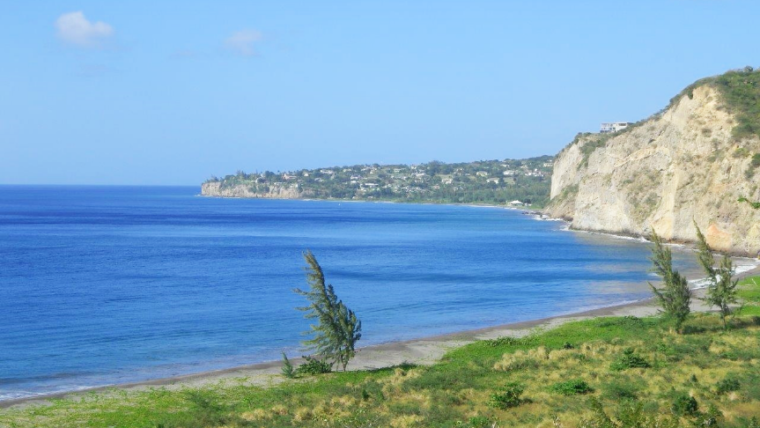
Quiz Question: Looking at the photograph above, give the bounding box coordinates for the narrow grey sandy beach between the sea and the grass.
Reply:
[0,266,760,409]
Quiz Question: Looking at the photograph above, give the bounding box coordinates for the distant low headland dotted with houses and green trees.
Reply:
[201,156,554,207]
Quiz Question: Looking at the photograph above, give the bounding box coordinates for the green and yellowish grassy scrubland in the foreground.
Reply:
[0,277,760,428]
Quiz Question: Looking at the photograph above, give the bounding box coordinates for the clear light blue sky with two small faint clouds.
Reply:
[0,0,760,185]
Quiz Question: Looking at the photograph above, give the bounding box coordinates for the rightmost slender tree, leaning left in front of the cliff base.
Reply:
[694,222,739,330]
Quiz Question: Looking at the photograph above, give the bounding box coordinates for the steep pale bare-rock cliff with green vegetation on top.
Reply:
[546,67,760,255]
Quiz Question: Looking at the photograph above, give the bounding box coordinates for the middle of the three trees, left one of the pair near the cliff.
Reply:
[649,230,691,332]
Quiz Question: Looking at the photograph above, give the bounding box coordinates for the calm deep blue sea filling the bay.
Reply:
[0,186,712,399]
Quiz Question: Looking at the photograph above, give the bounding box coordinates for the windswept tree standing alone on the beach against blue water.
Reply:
[293,250,362,371]
